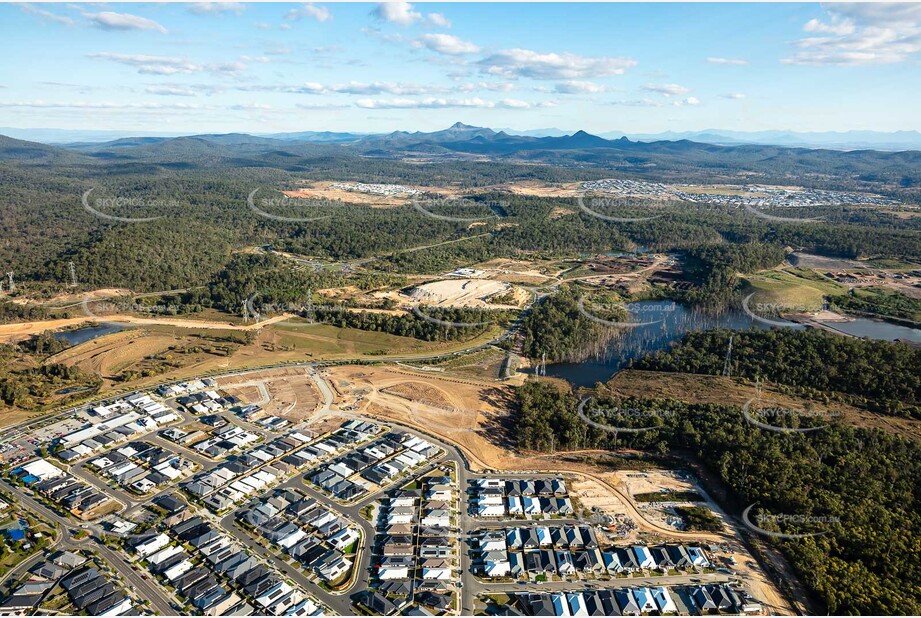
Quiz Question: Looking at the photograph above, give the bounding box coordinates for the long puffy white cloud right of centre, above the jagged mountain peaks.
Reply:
[479,49,637,79]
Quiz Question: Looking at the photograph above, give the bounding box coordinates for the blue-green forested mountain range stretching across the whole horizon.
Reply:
[0,122,921,187]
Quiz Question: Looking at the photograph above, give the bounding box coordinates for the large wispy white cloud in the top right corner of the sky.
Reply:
[781,2,921,66]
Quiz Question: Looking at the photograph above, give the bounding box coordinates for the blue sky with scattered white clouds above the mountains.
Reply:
[0,3,921,134]
